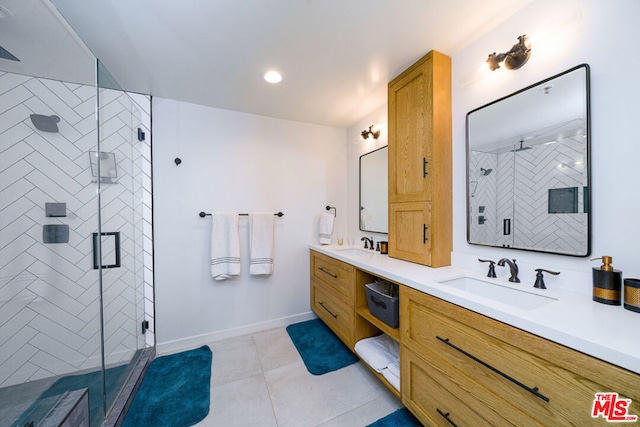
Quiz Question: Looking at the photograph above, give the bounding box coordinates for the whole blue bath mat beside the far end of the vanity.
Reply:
[287,319,359,375]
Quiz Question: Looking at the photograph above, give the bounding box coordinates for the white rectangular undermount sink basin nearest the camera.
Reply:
[440,276,557,310]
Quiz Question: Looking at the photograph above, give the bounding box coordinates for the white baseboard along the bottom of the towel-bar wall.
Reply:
[156,311,317,356]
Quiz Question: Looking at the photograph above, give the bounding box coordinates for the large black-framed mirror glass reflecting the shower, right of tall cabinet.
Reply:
[467,64,591,256]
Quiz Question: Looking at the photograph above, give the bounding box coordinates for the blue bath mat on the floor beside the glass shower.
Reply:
[122,345,212,427]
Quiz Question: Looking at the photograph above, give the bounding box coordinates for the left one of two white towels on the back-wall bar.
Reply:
[211,213,240,280]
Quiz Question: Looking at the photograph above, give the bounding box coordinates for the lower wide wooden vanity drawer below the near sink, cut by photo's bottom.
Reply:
[400,346,528,426]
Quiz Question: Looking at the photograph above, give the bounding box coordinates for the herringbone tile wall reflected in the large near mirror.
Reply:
[469,138,588,254]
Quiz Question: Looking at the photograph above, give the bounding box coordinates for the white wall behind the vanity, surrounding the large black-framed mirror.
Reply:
[348,0,640,294]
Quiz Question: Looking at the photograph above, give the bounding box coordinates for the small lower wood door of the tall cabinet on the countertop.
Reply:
[389,202,432,265]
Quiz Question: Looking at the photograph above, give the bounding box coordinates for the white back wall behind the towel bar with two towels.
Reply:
[153,98,347,352]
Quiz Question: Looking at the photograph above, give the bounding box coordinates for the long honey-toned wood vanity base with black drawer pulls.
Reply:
[310,250,640,426]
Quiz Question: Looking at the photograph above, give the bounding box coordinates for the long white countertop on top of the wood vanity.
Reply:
[310,244,640,374]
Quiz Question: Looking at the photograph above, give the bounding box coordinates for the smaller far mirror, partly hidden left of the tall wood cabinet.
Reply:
[360,146,389,233]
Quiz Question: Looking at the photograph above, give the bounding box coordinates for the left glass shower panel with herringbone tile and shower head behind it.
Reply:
[0,72,102,427]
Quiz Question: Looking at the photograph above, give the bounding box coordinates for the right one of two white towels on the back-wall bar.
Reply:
[249,212,274,276]
